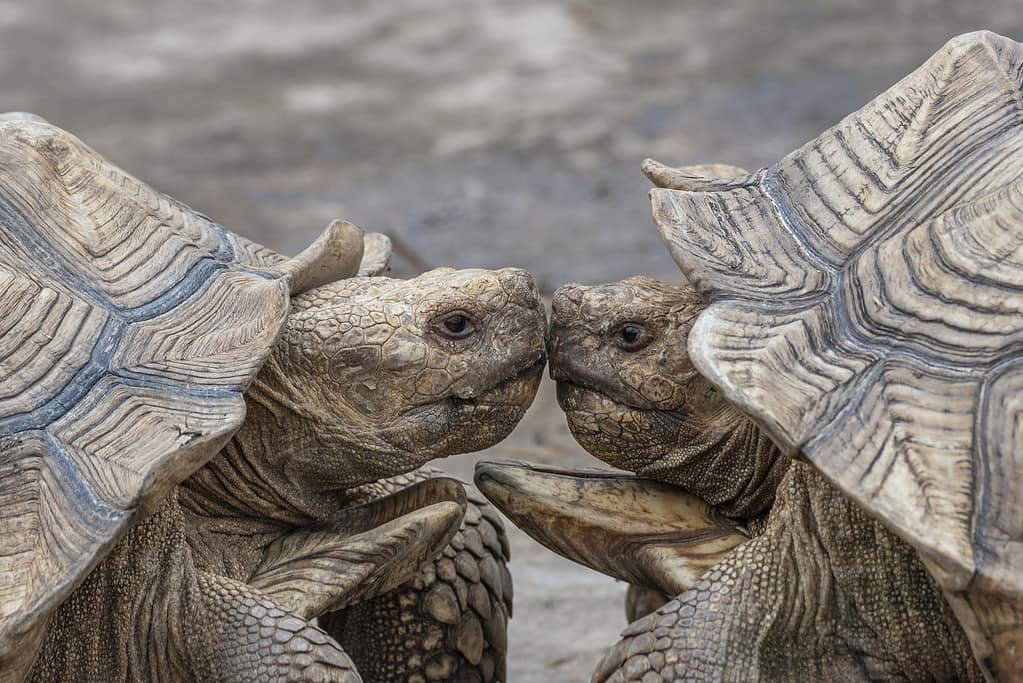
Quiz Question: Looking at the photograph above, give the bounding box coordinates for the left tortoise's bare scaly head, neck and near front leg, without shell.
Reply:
[30,269,545,682]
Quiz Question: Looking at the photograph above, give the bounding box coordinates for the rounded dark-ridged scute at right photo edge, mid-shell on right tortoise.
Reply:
[838,178,1023,367]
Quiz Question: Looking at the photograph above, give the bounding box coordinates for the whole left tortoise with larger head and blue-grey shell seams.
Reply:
[0,115,546,681]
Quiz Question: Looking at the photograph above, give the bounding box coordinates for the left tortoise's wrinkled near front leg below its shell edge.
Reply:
[30,492,361,683]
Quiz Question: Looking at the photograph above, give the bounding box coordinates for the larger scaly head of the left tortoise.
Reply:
[259,268,546,489]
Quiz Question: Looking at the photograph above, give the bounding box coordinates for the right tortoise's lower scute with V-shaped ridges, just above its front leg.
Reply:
[804,358,977,590]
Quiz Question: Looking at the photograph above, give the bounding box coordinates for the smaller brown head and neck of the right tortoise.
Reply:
[549,277,788,517]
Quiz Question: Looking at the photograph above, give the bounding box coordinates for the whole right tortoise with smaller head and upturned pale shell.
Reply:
[477,32,1023,681]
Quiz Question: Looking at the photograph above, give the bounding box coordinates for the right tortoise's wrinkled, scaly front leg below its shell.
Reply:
[592,463,983,683]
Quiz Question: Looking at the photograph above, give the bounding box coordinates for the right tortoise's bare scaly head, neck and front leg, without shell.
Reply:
[550,277,982,683]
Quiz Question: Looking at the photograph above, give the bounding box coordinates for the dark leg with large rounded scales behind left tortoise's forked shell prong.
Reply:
[319,467,512,683]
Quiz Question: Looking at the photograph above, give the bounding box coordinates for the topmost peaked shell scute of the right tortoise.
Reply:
[766,34,1023,264]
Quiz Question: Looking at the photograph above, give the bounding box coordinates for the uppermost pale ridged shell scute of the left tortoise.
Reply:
[0,120,230,312]
